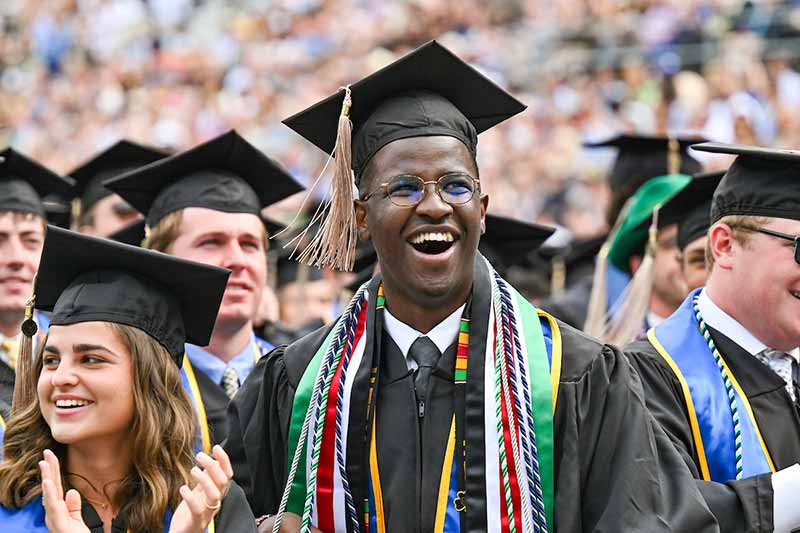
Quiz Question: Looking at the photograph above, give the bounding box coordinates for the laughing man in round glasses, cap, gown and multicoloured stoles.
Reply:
[226,41,716,532]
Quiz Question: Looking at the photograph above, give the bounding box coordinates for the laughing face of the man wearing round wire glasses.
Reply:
[356,136,488,312]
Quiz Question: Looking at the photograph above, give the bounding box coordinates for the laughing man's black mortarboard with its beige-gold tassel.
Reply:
[284,41,525,270]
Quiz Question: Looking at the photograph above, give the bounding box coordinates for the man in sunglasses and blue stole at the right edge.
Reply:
[626,143,800,532]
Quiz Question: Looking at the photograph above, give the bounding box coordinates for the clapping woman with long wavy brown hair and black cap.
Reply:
[0,227,255,533]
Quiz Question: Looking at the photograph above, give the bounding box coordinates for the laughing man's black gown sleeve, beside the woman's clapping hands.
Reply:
[224,348,294,516]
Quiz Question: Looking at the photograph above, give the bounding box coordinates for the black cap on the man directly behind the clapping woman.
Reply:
[104,130,303,228]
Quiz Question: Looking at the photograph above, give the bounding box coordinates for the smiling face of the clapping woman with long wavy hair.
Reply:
[37,322,135,445]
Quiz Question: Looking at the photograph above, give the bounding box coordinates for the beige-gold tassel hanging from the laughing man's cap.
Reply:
[297,87,358,271]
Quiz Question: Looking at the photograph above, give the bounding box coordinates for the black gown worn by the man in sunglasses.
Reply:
[625,327,800,532]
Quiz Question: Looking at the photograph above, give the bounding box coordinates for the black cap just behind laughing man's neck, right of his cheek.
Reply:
[478,214,555,274]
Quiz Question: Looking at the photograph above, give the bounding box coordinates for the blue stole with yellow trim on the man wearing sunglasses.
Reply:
[647,289,775,483]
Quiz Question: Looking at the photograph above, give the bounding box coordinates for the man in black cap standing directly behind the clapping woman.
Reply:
[105,131,302,450]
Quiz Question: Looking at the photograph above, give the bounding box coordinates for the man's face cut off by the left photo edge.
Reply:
[0,212,44,318]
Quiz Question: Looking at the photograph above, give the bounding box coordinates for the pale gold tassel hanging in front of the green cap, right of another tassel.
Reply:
[602,205,661,347]
